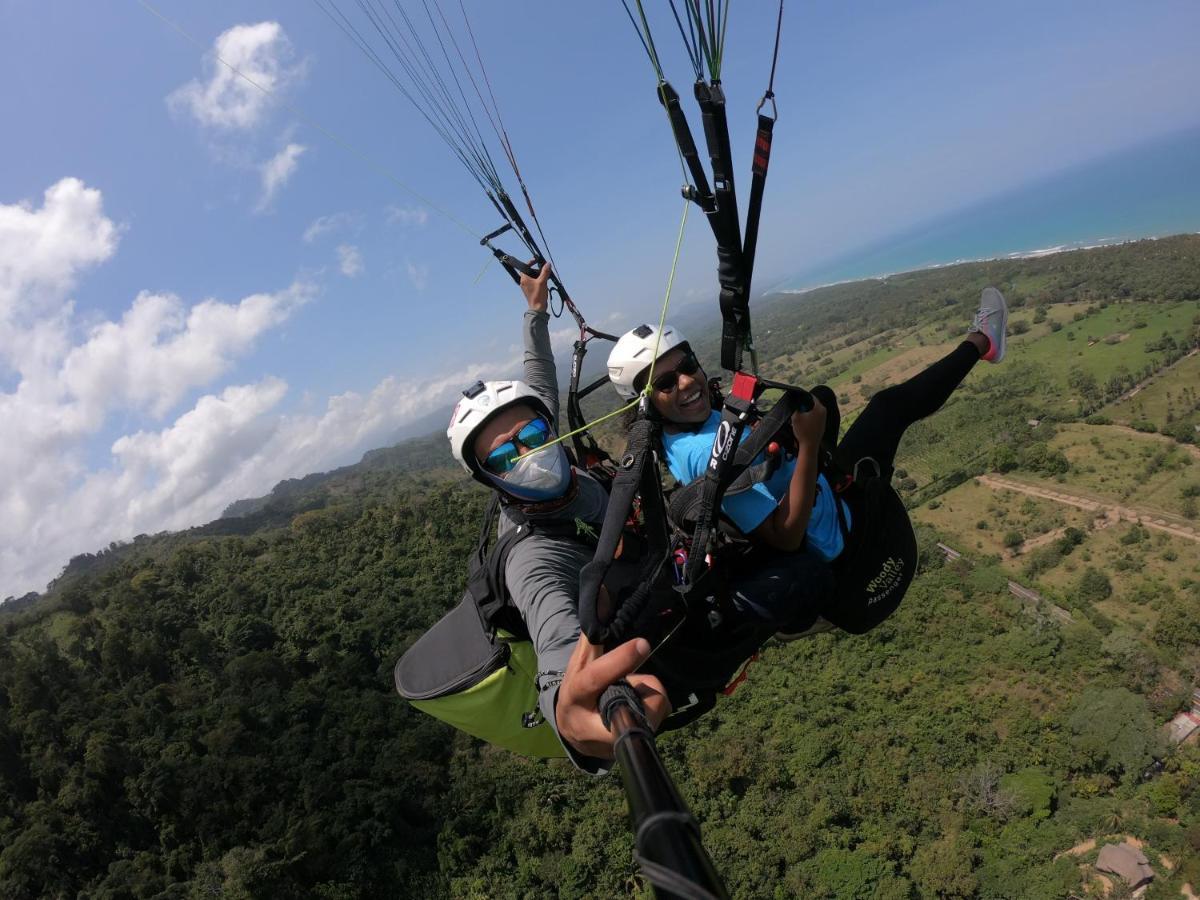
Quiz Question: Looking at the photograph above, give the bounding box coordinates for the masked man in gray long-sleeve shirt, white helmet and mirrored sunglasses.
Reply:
[446,265,667,773]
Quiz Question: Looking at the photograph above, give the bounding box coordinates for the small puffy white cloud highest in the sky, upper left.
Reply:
[167,22,302,131]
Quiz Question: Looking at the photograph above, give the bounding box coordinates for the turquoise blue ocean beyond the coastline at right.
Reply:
[774,127,1200,290]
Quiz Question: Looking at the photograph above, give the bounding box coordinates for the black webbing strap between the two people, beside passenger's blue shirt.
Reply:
[580,418,667,644]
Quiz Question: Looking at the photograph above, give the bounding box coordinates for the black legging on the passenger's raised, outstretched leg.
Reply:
[830,341,979,478]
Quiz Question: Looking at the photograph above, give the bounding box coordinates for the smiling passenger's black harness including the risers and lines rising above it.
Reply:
[580,0,916,700]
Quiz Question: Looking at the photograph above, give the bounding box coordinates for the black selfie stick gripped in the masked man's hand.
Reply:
[600,682,728,900]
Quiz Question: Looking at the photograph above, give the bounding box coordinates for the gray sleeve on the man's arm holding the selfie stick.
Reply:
[504,534,612,775]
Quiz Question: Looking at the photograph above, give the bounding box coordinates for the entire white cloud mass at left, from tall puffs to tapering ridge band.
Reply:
[0,180,549,596]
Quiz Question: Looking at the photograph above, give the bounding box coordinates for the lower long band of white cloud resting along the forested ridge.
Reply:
[0,356,520,595]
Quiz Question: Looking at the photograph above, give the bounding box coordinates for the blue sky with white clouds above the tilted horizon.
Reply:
[0,0,1200,596]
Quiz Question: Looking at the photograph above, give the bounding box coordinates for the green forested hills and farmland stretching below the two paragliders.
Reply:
[0,236,1200,898]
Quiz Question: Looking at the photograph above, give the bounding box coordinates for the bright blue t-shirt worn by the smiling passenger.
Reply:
[662,409,850,559]
